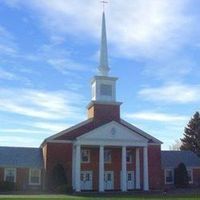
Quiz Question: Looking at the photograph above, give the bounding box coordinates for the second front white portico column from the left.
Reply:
[99,146,104,192]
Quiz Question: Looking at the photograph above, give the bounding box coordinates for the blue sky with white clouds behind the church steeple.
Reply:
[0,0,200,149]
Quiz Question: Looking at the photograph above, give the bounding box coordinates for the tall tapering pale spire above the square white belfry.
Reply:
[98,11,110,76]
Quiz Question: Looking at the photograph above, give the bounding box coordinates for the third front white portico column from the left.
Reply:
[121,146,127,192]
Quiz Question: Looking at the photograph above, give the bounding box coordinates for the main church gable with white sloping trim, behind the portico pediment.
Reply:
[41,118,162,146]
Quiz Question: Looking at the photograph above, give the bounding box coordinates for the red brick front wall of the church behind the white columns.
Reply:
[43,143,165,191]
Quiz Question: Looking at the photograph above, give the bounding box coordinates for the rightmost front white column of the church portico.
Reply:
[143,147,149,191]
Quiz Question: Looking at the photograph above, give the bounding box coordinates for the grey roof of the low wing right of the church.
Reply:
[161,151,200,168]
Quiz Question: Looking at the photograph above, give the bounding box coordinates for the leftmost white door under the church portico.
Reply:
[81,171,92,190]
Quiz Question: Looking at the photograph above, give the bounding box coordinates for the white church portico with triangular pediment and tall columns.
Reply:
[73,121,149,192]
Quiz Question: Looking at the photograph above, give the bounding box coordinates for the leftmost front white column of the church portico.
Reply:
[75,145,81,192]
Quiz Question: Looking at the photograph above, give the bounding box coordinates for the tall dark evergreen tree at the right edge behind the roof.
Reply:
[180,112,200,156]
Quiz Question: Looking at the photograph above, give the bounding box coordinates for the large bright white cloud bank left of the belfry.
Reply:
[0,89,84,120]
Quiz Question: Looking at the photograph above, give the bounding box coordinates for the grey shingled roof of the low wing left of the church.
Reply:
[0,147,43,169]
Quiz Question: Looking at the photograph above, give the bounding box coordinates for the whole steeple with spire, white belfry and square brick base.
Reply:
[88,11,121,123]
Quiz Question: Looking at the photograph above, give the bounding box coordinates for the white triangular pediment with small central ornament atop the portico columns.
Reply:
[77,121,148,143]
